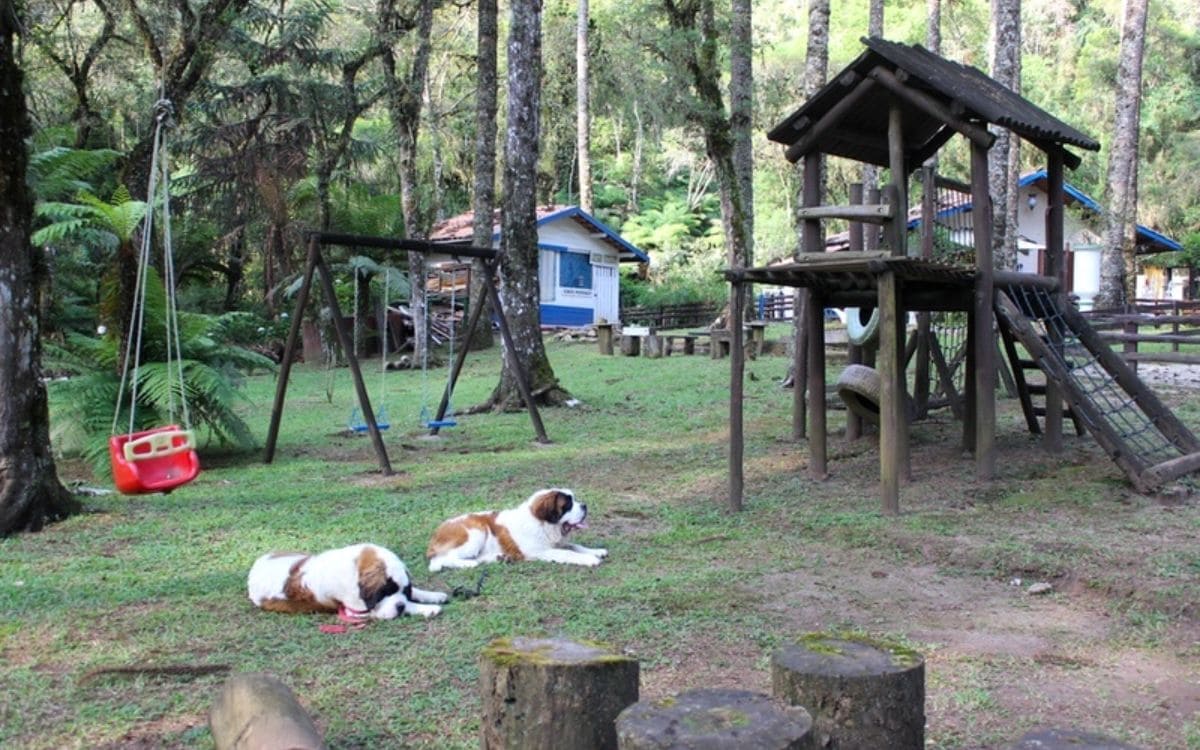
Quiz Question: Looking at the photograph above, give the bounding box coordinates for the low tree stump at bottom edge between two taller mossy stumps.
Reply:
[617,689,816,750]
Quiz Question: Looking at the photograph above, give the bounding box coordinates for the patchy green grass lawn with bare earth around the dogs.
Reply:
[0,342,1200,750]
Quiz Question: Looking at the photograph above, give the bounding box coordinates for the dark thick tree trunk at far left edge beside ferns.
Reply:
[0,14,79,536]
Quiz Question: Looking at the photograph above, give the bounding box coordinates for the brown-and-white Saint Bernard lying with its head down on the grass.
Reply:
[246,544,449,622]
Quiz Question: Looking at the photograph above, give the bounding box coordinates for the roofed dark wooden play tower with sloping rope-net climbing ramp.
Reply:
[726,37,1200,515]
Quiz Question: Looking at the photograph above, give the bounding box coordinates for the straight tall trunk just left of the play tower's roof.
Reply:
[730,0,754,266]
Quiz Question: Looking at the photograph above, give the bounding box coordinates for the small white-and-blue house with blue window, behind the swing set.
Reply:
[430,205,650,328]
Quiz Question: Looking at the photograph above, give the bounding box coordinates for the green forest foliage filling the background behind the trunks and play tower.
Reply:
[19,0,1200,321]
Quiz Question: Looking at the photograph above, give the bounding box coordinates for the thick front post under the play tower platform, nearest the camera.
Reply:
[878,271,908,516]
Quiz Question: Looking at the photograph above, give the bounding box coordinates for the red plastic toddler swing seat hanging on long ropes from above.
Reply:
[108,100,200,494]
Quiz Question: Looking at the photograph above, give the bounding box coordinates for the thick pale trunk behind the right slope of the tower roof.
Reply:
[988,0,1021,270]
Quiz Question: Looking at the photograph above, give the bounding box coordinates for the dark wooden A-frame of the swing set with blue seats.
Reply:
[263,232,550,475]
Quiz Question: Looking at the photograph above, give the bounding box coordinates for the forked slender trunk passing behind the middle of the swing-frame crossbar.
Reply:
[379,0,434,362]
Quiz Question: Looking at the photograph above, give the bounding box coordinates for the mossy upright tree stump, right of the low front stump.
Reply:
[770,632,925,750]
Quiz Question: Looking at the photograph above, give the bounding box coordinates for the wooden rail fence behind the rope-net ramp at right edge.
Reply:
[1084,300,1200,365]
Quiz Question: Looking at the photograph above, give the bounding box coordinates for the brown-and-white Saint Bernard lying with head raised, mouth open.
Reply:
[425,487,608,572]
